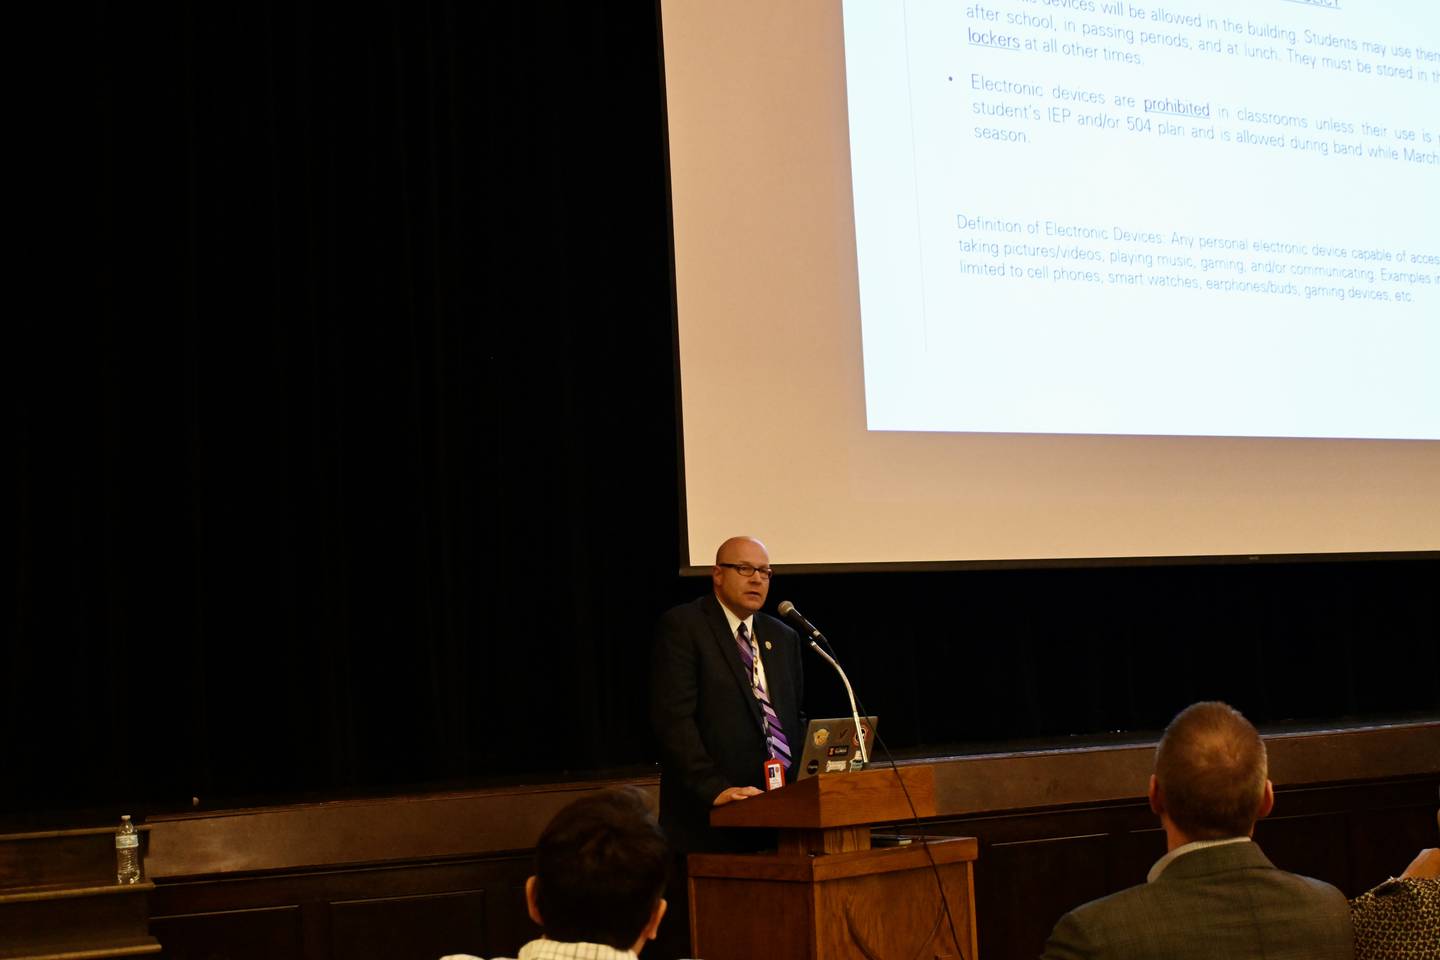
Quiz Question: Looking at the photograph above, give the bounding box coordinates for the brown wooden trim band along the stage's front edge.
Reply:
[137,720,1440,881]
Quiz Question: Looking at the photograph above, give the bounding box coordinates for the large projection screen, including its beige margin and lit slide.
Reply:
[660,0,1440,569]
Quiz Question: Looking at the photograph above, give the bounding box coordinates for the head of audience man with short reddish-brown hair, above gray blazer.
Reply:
[1151,701,1274,848]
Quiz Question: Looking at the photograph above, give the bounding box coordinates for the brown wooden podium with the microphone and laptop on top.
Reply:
[688,766,978,960]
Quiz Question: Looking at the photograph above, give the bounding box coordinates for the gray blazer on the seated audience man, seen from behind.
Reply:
[1044,843,1354,960]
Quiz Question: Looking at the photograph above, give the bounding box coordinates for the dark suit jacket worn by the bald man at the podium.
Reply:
[649,594,805,852]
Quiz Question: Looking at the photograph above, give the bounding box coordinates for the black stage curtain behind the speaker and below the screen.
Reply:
[8,0,1440,823]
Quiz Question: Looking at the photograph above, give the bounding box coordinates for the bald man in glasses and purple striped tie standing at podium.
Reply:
[651,537,805,858]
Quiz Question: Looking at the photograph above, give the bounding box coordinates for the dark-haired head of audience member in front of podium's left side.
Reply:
[526,787,670,953]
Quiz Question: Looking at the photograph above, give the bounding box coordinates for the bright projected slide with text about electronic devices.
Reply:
[844,0,1440,439]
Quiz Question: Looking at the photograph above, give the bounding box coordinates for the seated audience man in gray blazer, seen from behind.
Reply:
[1044,702,1355,960]
